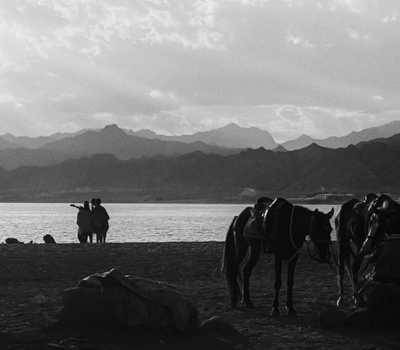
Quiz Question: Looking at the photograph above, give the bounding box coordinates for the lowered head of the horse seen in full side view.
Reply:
[309,208,335,262]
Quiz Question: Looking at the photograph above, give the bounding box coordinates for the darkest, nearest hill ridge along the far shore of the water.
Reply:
[0,136,400,201]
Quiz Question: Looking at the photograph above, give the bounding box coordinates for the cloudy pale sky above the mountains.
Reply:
[0,0,400,141]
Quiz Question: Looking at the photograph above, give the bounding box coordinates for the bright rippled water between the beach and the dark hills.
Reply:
[0,203,339,243]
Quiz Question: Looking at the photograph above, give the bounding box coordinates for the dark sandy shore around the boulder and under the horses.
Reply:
[0,242,400,349]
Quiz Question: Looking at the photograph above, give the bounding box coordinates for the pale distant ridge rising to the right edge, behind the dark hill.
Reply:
[282,120,400,150]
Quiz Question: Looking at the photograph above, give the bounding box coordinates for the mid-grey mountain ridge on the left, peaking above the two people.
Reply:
[0,125,239,170]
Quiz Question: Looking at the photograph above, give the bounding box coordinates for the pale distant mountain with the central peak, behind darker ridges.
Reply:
[130,123,278,149]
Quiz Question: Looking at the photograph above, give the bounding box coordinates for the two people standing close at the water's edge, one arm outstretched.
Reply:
[71,198,110,243]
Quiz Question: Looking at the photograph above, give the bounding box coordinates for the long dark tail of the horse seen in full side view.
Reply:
[222,216,240,307]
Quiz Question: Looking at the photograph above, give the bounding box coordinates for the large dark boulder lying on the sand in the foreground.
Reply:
[61,269,198,331]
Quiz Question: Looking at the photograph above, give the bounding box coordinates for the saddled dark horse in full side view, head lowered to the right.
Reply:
[223,198,334,316]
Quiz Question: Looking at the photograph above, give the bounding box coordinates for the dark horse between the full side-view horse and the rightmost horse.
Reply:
[335,193,378,307]
